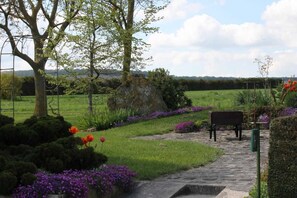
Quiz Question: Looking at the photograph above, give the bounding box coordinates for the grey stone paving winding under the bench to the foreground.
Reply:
[124,130,269,198]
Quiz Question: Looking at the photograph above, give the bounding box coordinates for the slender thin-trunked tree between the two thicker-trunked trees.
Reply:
[58,0,119,112]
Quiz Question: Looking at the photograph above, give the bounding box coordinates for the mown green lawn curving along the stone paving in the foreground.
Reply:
[79,111,222,179]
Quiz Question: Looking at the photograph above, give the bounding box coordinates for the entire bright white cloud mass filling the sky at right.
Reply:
[148,0,297,77]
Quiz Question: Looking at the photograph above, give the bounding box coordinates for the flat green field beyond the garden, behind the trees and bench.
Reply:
[1,90,240,126]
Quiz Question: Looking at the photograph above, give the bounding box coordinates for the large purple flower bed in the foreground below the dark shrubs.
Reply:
[13,165,136,198]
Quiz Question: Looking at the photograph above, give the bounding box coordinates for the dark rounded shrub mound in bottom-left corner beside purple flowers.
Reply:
[0,171,18,195]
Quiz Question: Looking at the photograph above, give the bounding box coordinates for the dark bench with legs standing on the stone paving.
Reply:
[209,111,243,141]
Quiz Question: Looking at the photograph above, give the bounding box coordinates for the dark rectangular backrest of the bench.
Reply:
[210,111,243,125]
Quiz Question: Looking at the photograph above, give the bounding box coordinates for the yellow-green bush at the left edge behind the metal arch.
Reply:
[0,73,22,100]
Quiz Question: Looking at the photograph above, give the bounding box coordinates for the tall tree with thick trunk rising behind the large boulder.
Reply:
[104,0,168,82]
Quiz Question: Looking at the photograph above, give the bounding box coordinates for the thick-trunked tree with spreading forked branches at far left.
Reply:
[0,0,81,117]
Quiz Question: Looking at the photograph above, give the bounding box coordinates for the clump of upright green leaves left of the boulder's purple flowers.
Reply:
[82,108,135,130]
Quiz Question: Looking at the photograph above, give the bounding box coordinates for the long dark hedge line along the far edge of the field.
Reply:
[1,74,286,99]
